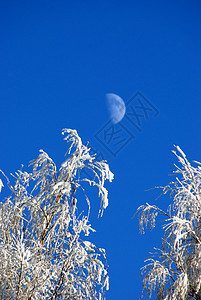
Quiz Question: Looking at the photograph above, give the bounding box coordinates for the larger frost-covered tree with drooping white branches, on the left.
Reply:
[0,129,113,300]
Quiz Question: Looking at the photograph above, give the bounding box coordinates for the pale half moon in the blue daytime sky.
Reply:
[106,93,126,124]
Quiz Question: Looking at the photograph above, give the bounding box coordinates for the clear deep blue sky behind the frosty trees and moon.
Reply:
[0,0,201,300]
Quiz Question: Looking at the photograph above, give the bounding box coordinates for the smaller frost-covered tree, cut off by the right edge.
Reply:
[138,146,201,300]
